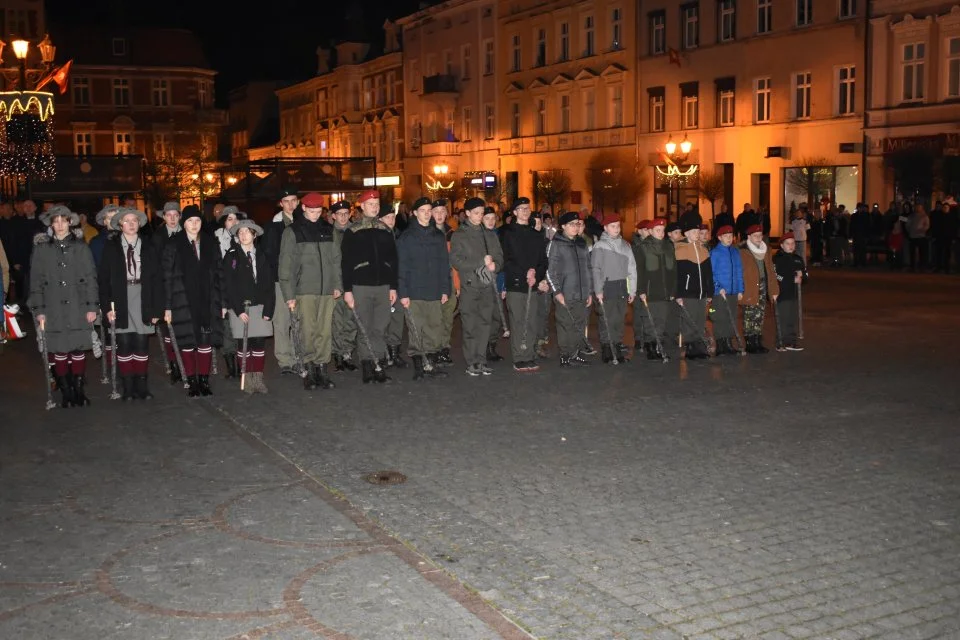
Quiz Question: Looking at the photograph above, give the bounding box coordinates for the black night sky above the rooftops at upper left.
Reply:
[46,0,420,104]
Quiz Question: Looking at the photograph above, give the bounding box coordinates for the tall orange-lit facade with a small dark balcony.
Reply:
[397,0,500,198]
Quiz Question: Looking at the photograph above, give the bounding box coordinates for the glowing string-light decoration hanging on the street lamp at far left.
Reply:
[0,91,57,182]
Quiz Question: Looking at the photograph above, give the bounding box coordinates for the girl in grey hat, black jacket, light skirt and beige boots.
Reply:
[223,220,276,393]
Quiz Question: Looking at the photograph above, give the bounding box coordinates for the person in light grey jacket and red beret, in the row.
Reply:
[590,213,637,362]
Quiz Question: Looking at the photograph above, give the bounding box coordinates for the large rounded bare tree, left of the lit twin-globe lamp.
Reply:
[585,149,649,212]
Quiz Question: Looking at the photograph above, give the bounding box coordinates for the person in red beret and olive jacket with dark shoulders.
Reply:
[277,193,349,391]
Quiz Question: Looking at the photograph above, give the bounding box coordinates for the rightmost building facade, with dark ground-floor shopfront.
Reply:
[864,0,960,208]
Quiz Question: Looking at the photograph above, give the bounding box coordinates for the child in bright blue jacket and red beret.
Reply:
[710,225,743,356]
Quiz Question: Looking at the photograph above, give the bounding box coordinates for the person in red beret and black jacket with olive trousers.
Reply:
[340,189,397,383]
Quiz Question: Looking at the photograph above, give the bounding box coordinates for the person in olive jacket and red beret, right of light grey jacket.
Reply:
[633,218,677,360]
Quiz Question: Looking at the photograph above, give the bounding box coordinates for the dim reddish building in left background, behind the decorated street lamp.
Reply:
[51,26,227,162]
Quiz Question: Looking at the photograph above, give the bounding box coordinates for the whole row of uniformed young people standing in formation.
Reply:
[29,190,807,407]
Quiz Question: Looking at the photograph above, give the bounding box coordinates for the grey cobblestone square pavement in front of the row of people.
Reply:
[0,271,960,640]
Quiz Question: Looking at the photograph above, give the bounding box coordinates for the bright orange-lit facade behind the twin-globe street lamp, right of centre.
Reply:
[637,0,867,235]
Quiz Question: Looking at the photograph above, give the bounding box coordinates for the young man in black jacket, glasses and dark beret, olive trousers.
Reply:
[502,198,549,371]
